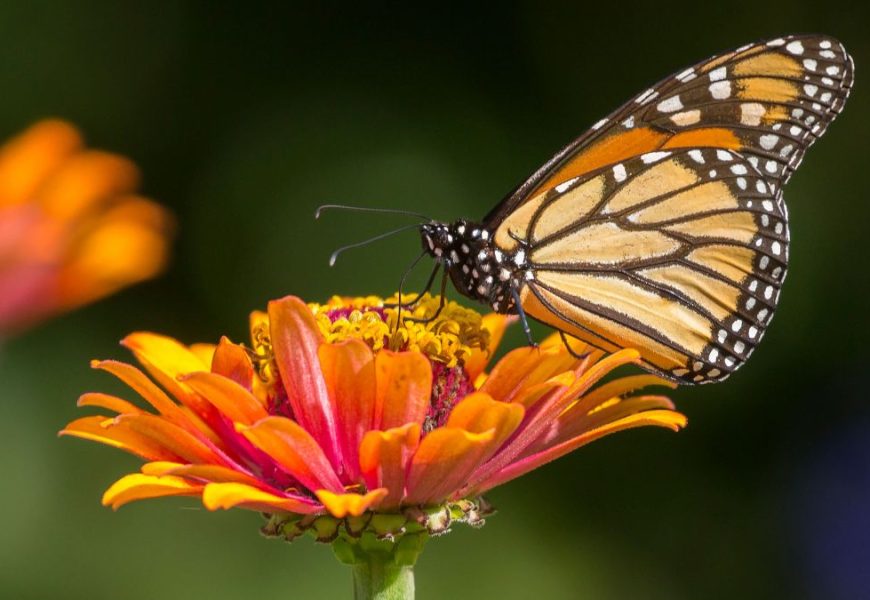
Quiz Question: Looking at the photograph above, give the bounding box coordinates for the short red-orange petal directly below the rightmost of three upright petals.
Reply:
[359,423,420,510]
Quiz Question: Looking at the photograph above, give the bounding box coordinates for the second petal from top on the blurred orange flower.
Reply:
[39,150,139,220]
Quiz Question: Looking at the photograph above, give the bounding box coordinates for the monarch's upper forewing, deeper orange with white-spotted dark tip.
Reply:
[484,35,853,223]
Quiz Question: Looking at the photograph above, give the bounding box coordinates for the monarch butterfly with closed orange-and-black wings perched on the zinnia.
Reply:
[324,35,853,383]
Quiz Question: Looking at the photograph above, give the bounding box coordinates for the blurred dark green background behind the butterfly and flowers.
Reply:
[0,0,870,600]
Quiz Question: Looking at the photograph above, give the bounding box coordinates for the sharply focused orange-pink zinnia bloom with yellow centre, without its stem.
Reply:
[61,295,686,519]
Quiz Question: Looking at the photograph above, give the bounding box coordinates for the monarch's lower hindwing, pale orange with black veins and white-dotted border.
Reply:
[494,148,788,383]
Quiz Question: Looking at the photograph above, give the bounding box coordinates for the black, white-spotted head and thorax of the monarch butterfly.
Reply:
[420,220,526,313]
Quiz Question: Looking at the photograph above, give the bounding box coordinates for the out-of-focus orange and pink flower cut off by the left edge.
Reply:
[0,120,171,337]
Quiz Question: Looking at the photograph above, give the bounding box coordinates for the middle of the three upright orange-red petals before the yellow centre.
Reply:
[318,339,376,481]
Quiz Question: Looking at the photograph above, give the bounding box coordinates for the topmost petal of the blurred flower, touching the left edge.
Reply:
[0,119,82,206]
